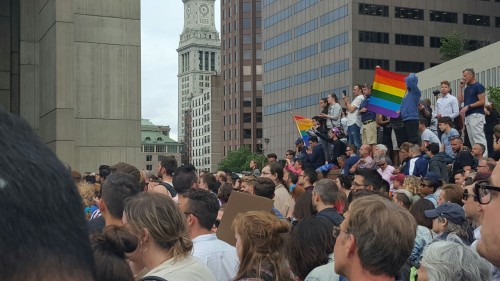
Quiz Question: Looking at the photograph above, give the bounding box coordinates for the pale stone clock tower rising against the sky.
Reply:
[177,0,221,148]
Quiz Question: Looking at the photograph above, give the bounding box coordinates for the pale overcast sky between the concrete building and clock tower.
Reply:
[141,0,220,140]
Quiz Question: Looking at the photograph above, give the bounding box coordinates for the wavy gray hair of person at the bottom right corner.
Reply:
[420,234,491,281]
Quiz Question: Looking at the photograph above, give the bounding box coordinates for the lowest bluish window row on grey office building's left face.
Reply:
[264,59,349,94]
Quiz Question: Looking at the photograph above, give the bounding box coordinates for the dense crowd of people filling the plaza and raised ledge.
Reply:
[0,69,500,281]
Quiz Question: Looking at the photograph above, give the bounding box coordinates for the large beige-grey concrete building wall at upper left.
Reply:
[15,0,141,171]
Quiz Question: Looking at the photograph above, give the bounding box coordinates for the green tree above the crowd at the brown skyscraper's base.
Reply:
[219,146,267,173]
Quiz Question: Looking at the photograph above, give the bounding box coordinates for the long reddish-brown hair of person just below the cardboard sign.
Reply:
[232,211,292,280]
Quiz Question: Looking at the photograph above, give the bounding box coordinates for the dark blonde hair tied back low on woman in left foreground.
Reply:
[124,192,193,261]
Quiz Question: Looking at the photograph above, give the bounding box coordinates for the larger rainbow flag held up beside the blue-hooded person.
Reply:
[366,67,406,118]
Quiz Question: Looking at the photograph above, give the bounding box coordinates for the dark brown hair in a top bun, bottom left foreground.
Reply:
[90,225,138,281]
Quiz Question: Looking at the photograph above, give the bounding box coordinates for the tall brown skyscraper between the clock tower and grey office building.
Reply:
[221,0,264,157]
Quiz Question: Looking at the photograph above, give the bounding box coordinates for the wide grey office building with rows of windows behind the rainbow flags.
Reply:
[262,0,500,155]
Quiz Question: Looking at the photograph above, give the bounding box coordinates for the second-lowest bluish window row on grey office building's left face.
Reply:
[264,32,349,72]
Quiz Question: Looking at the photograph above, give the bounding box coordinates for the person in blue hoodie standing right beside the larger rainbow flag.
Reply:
[399,73,422,144]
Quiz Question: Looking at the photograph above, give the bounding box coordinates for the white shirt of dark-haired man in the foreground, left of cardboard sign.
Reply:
[193,234,240,281]
